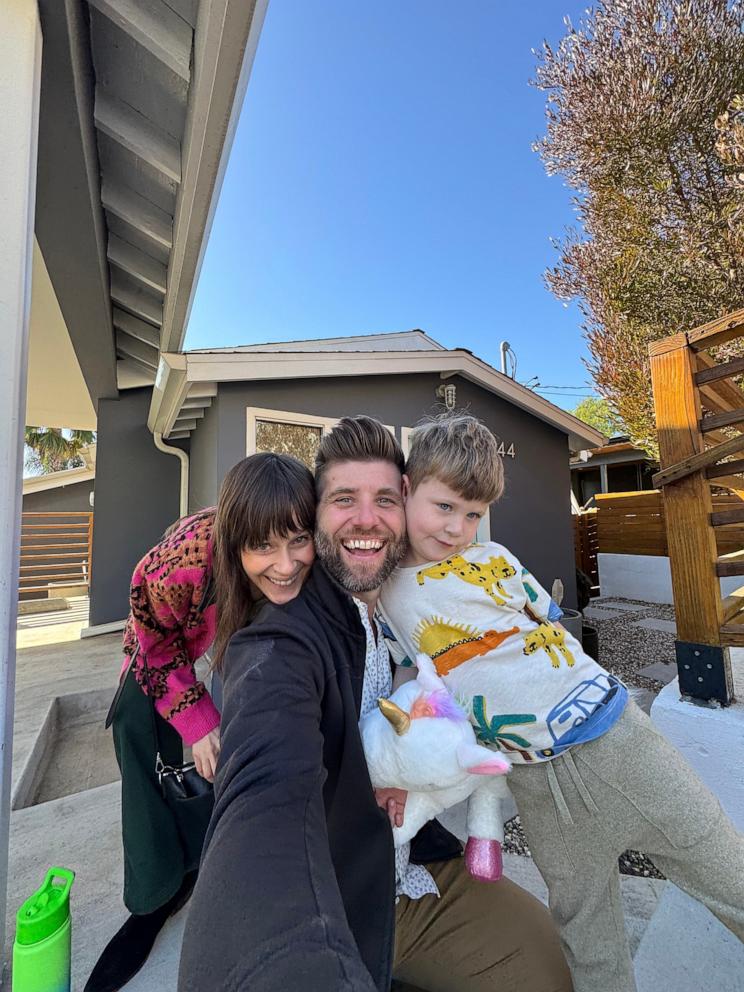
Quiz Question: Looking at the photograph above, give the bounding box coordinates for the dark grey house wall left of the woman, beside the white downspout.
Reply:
[90,388,180,626]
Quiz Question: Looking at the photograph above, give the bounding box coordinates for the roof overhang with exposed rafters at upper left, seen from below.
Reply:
[32,0,267,427]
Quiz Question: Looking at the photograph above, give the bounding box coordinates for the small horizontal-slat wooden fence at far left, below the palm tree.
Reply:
[18,512,93,598]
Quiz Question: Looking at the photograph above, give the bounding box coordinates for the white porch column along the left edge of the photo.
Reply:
[0,0,41,960]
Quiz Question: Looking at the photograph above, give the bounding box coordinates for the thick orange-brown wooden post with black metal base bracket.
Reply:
[651,335,732,704]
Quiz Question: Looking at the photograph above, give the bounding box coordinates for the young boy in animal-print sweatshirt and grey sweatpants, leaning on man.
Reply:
[381,414,744,992]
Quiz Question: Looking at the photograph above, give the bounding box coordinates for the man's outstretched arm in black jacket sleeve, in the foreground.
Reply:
[178,621,375,992]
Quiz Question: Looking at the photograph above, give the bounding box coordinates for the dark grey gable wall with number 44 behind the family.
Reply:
[192,375,576,607]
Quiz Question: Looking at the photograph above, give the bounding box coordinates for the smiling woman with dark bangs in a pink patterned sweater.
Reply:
[85,453,315,992]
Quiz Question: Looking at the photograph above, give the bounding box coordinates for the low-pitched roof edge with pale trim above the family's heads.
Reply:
[148,331,604,451]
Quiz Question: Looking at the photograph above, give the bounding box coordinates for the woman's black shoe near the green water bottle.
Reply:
[83,871,196,992]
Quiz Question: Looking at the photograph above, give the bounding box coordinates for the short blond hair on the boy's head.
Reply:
[406,411,504,503]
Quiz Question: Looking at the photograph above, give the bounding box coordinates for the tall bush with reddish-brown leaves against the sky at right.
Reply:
[534,0,744,451]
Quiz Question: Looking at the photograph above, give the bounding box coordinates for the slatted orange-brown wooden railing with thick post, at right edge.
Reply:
[649,309,744,706]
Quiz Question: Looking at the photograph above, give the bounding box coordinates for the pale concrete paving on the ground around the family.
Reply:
[5,614,744,992]
